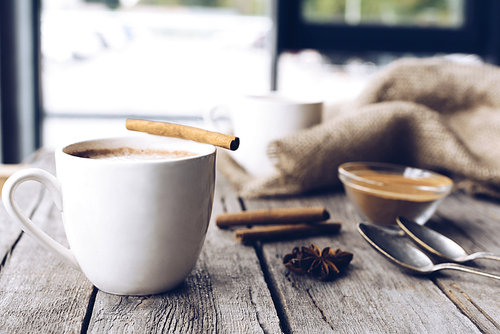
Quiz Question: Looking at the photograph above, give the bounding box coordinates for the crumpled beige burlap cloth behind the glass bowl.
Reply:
[218,58,500,198]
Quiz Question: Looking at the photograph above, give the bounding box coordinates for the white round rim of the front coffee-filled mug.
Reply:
[56,134,217,164]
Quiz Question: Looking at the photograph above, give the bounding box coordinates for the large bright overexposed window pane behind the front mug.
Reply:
[41,0,272,146]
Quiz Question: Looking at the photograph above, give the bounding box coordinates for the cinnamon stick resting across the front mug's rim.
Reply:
[125,118,240,151]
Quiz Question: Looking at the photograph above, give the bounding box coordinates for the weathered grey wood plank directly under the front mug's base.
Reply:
[88,175,281,333]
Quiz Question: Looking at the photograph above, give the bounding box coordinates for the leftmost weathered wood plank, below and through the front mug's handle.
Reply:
[0,152,93,333]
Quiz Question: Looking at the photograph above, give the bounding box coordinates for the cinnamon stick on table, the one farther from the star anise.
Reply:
[215,207,330,228]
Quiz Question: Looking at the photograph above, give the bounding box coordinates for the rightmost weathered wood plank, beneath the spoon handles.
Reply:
[428,194,500,333]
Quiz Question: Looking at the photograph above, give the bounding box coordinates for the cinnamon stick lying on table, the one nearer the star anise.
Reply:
[234,222,342,243]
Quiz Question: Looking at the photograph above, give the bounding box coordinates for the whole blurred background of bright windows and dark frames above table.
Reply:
[0,0,500,162]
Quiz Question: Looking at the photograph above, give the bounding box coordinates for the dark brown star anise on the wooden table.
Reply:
[283,244,353,281]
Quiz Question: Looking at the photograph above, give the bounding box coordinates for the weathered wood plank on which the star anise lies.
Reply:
[244,193,484,333]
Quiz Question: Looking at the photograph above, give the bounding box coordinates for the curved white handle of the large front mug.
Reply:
[2,168,80,270]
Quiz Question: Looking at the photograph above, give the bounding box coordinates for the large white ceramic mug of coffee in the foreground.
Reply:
[2,134,216,295]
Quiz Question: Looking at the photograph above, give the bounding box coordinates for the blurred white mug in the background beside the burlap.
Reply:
[206,92,323,176]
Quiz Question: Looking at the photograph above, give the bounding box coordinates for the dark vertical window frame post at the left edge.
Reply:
[0,0,42,164]
